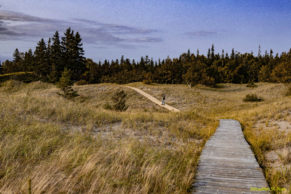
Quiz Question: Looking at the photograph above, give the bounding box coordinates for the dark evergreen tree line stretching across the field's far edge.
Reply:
[0,28,291,86]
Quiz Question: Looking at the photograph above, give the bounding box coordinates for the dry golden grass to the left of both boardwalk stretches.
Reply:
[0,81,216,193]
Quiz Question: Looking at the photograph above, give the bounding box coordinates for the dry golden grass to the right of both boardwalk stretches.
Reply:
[131,83,291,193]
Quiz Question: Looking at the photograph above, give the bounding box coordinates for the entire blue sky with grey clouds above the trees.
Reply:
[0,0,291,60]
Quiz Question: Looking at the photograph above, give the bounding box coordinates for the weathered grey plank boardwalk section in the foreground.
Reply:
[193,119,269,194]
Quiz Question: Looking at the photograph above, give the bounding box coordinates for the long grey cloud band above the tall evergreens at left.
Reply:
[0,10,163,48]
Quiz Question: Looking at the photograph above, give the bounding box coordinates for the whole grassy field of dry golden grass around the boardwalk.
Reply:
[0,81,291,193]
